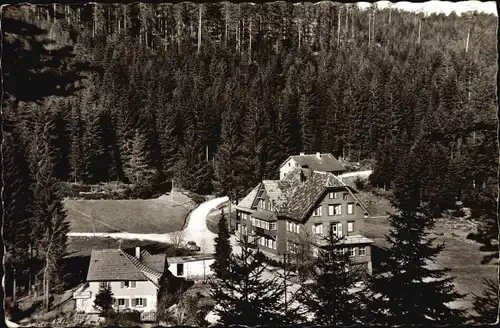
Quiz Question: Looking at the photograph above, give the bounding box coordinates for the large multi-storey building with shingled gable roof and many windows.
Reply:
[236,168,373,273]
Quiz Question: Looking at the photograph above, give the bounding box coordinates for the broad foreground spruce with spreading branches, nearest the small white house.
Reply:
[210,239,300,326]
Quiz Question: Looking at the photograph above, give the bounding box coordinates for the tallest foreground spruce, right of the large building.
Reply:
[368,139,464,325]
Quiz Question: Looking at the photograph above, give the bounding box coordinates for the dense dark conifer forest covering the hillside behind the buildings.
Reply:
[2,2,498,322]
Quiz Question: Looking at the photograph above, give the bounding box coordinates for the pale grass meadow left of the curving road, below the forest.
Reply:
[64,192,196,234]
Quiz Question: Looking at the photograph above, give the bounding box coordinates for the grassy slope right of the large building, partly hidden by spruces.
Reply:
[364,218,498,308]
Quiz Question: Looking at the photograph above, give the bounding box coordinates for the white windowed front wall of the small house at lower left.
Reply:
[76,281,157,313]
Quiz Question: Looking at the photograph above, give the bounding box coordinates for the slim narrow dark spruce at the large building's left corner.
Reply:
[210,209,233,279]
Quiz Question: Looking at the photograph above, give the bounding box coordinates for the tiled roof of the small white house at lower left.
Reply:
[87,249,165,281]
